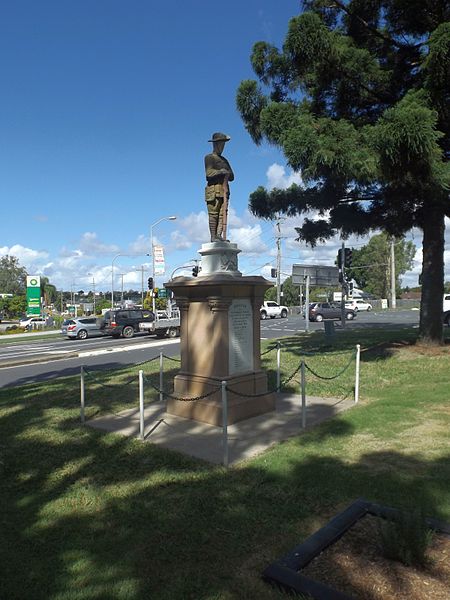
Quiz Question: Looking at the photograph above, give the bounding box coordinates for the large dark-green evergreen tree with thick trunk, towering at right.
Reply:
[237,0,450,343]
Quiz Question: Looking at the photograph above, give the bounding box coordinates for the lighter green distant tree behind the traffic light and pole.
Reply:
[345,233,416,298]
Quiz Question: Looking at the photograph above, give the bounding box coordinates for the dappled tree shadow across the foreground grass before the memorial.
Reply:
[0,380,450,600]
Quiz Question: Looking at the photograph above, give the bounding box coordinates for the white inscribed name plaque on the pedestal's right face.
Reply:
[228,299,254,375]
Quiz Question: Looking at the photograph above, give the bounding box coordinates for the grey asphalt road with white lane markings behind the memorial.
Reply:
[0,310,419,387]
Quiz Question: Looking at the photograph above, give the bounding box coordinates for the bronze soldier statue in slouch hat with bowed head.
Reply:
[205,133,234,242]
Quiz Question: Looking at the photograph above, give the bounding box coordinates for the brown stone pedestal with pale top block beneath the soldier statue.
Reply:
[166,242,275,425]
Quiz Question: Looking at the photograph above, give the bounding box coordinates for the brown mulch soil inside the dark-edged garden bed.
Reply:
[301,516,450,600]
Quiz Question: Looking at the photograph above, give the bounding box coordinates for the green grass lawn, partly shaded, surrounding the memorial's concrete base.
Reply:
[0,330,450,600]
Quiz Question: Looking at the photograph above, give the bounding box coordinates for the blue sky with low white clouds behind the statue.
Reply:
[0,0,450,290]
